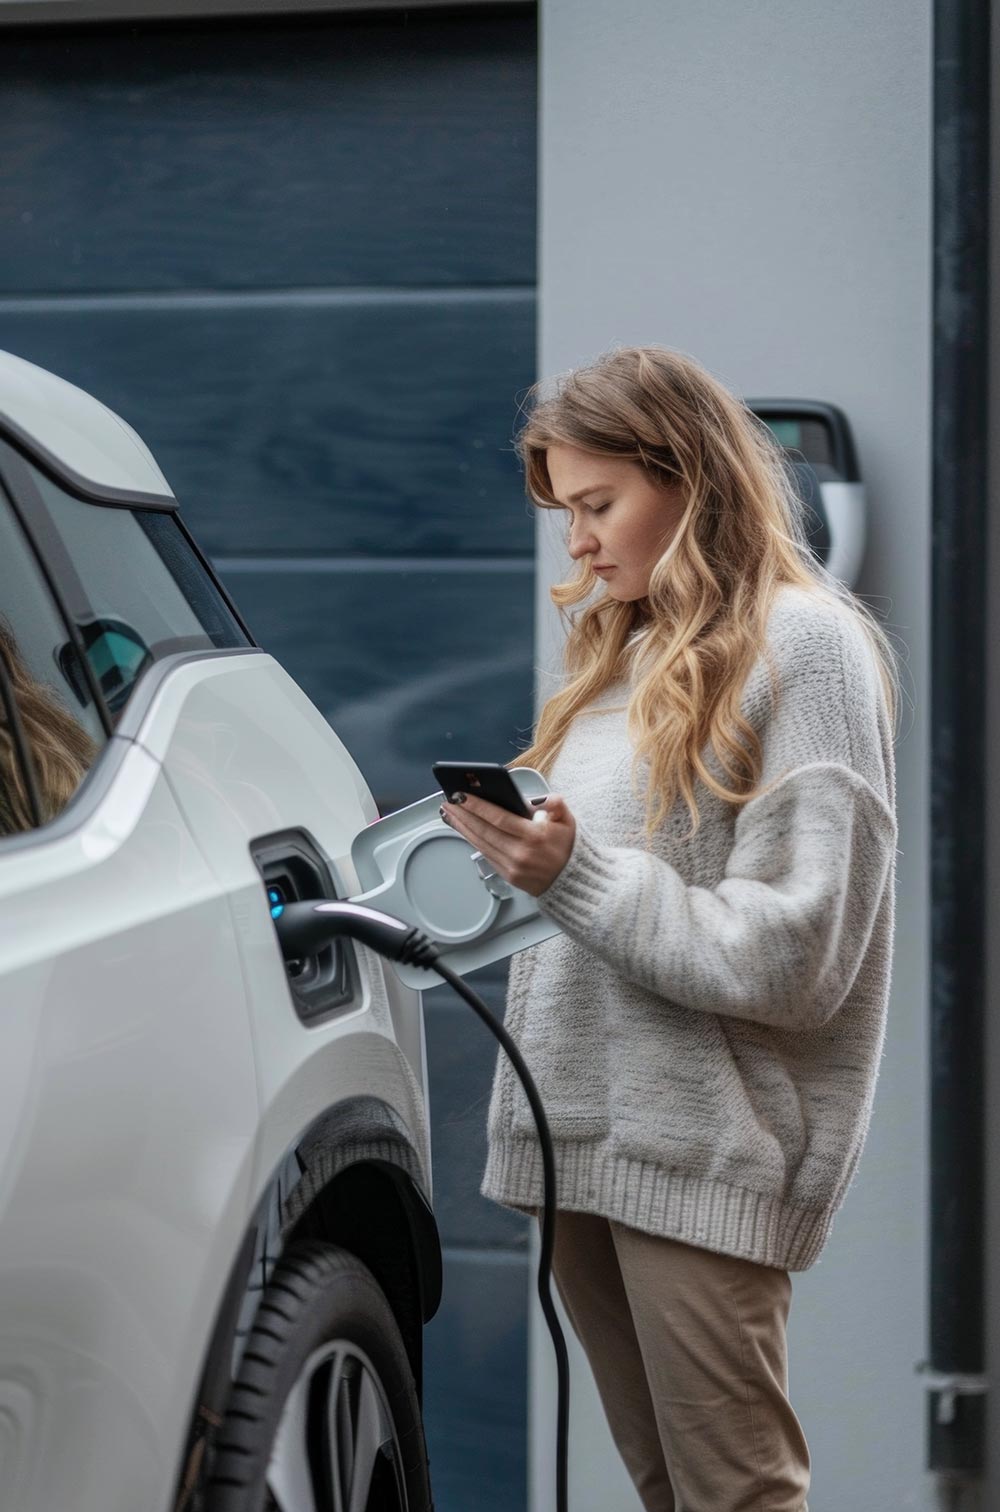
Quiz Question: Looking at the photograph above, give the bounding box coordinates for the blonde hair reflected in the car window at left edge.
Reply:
[0,618,97,835]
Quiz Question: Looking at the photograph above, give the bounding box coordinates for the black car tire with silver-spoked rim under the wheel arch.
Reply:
[204,1240,433,1512]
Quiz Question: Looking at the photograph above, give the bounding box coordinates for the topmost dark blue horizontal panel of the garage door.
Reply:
[0,12,536,292]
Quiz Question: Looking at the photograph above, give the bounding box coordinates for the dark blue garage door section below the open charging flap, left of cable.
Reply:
[424,962,531,1252]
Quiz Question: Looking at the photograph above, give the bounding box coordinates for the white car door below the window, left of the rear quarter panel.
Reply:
[0,747,259,1512]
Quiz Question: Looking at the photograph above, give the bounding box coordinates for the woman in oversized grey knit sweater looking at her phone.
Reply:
[442,346,899,1512]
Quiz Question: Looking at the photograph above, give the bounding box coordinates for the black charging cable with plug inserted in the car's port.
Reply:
[271,901,569,1512]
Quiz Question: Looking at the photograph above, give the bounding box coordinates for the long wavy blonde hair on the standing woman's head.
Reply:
[507,346,899,844]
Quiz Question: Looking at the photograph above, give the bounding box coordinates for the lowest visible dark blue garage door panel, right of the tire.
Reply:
[424,1252,534,1512]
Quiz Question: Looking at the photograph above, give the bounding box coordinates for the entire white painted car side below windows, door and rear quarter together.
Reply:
[0,652,430,1512]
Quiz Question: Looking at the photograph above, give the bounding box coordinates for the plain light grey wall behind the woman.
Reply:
[531,0,937,1512]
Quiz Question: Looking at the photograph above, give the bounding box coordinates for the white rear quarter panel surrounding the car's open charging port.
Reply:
[136,653,431,1198]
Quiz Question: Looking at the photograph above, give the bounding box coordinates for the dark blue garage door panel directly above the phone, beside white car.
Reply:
[214,561,534,813]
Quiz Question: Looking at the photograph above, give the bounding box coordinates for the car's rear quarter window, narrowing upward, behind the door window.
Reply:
[30,464,250,718]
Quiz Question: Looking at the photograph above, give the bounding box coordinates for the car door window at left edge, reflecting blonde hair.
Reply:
[0,499,104,838]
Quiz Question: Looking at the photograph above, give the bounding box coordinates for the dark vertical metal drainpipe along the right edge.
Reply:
[926,0,991,1477]
